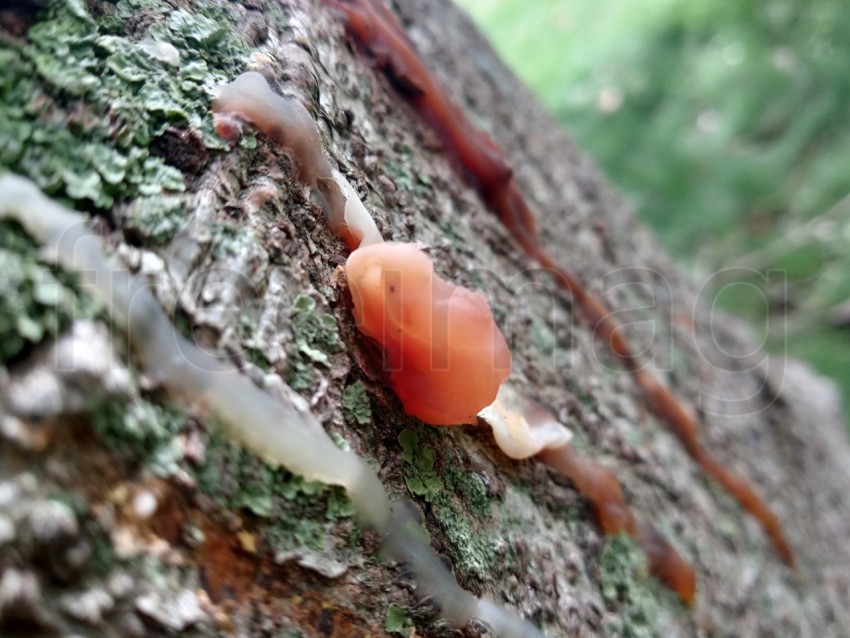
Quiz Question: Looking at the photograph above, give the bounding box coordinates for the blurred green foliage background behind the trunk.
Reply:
[458,0,850,414]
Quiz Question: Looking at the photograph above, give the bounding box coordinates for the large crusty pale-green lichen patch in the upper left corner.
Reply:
[0,0,244,209]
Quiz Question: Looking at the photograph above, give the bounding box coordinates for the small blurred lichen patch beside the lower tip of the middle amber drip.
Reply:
[599,534,660,638]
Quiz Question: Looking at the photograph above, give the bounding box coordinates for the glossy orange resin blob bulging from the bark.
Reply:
[345,242,511,425]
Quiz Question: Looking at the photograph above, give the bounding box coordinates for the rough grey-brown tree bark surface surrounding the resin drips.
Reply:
[0,0,850,637]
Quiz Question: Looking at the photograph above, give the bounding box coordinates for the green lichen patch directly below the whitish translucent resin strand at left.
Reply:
[193,431,354,551]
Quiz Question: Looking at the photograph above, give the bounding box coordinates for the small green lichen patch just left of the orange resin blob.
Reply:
[286,295,344,390]
